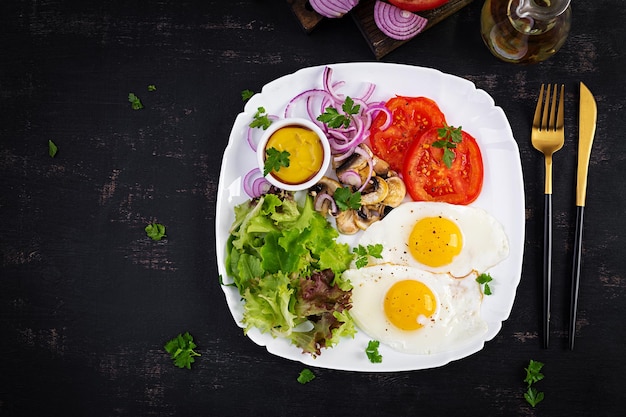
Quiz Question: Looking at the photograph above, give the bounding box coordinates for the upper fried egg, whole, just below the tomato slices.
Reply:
[358,202,509,277]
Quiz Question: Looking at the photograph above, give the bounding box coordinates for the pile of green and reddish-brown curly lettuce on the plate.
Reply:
[226,193,356,356]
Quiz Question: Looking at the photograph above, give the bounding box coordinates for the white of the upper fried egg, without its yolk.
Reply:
[358,202,509,277]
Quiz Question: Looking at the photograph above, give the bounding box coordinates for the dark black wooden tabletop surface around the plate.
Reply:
[0,0,626,417]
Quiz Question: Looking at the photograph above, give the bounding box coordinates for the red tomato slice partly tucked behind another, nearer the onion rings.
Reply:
[370,96,446,172]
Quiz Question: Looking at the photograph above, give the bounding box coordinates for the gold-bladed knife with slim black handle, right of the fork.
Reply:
[569,82,598,350]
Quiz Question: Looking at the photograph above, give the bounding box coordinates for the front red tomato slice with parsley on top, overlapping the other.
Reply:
[402,128,484,205]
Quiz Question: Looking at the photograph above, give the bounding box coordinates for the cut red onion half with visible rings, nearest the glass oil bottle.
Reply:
[374,0,428,41]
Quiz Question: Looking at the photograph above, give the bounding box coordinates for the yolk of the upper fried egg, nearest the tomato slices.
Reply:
[408,216,463,267]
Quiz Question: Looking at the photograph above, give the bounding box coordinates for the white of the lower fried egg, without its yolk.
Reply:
[343,265,487,355]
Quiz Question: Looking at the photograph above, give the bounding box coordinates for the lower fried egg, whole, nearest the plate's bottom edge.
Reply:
[343,265,487,354]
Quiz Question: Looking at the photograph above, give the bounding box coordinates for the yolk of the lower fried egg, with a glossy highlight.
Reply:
[385,280,437,330]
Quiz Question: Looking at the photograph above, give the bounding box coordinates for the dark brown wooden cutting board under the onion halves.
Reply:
[287,0,474,59]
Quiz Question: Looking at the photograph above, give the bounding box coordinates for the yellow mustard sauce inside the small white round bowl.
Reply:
[265,126,324,184]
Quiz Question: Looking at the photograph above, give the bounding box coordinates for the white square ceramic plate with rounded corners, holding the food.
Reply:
[216,63,525,372]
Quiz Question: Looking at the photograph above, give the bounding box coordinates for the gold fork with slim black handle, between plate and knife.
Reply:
[531,84,565,348]
